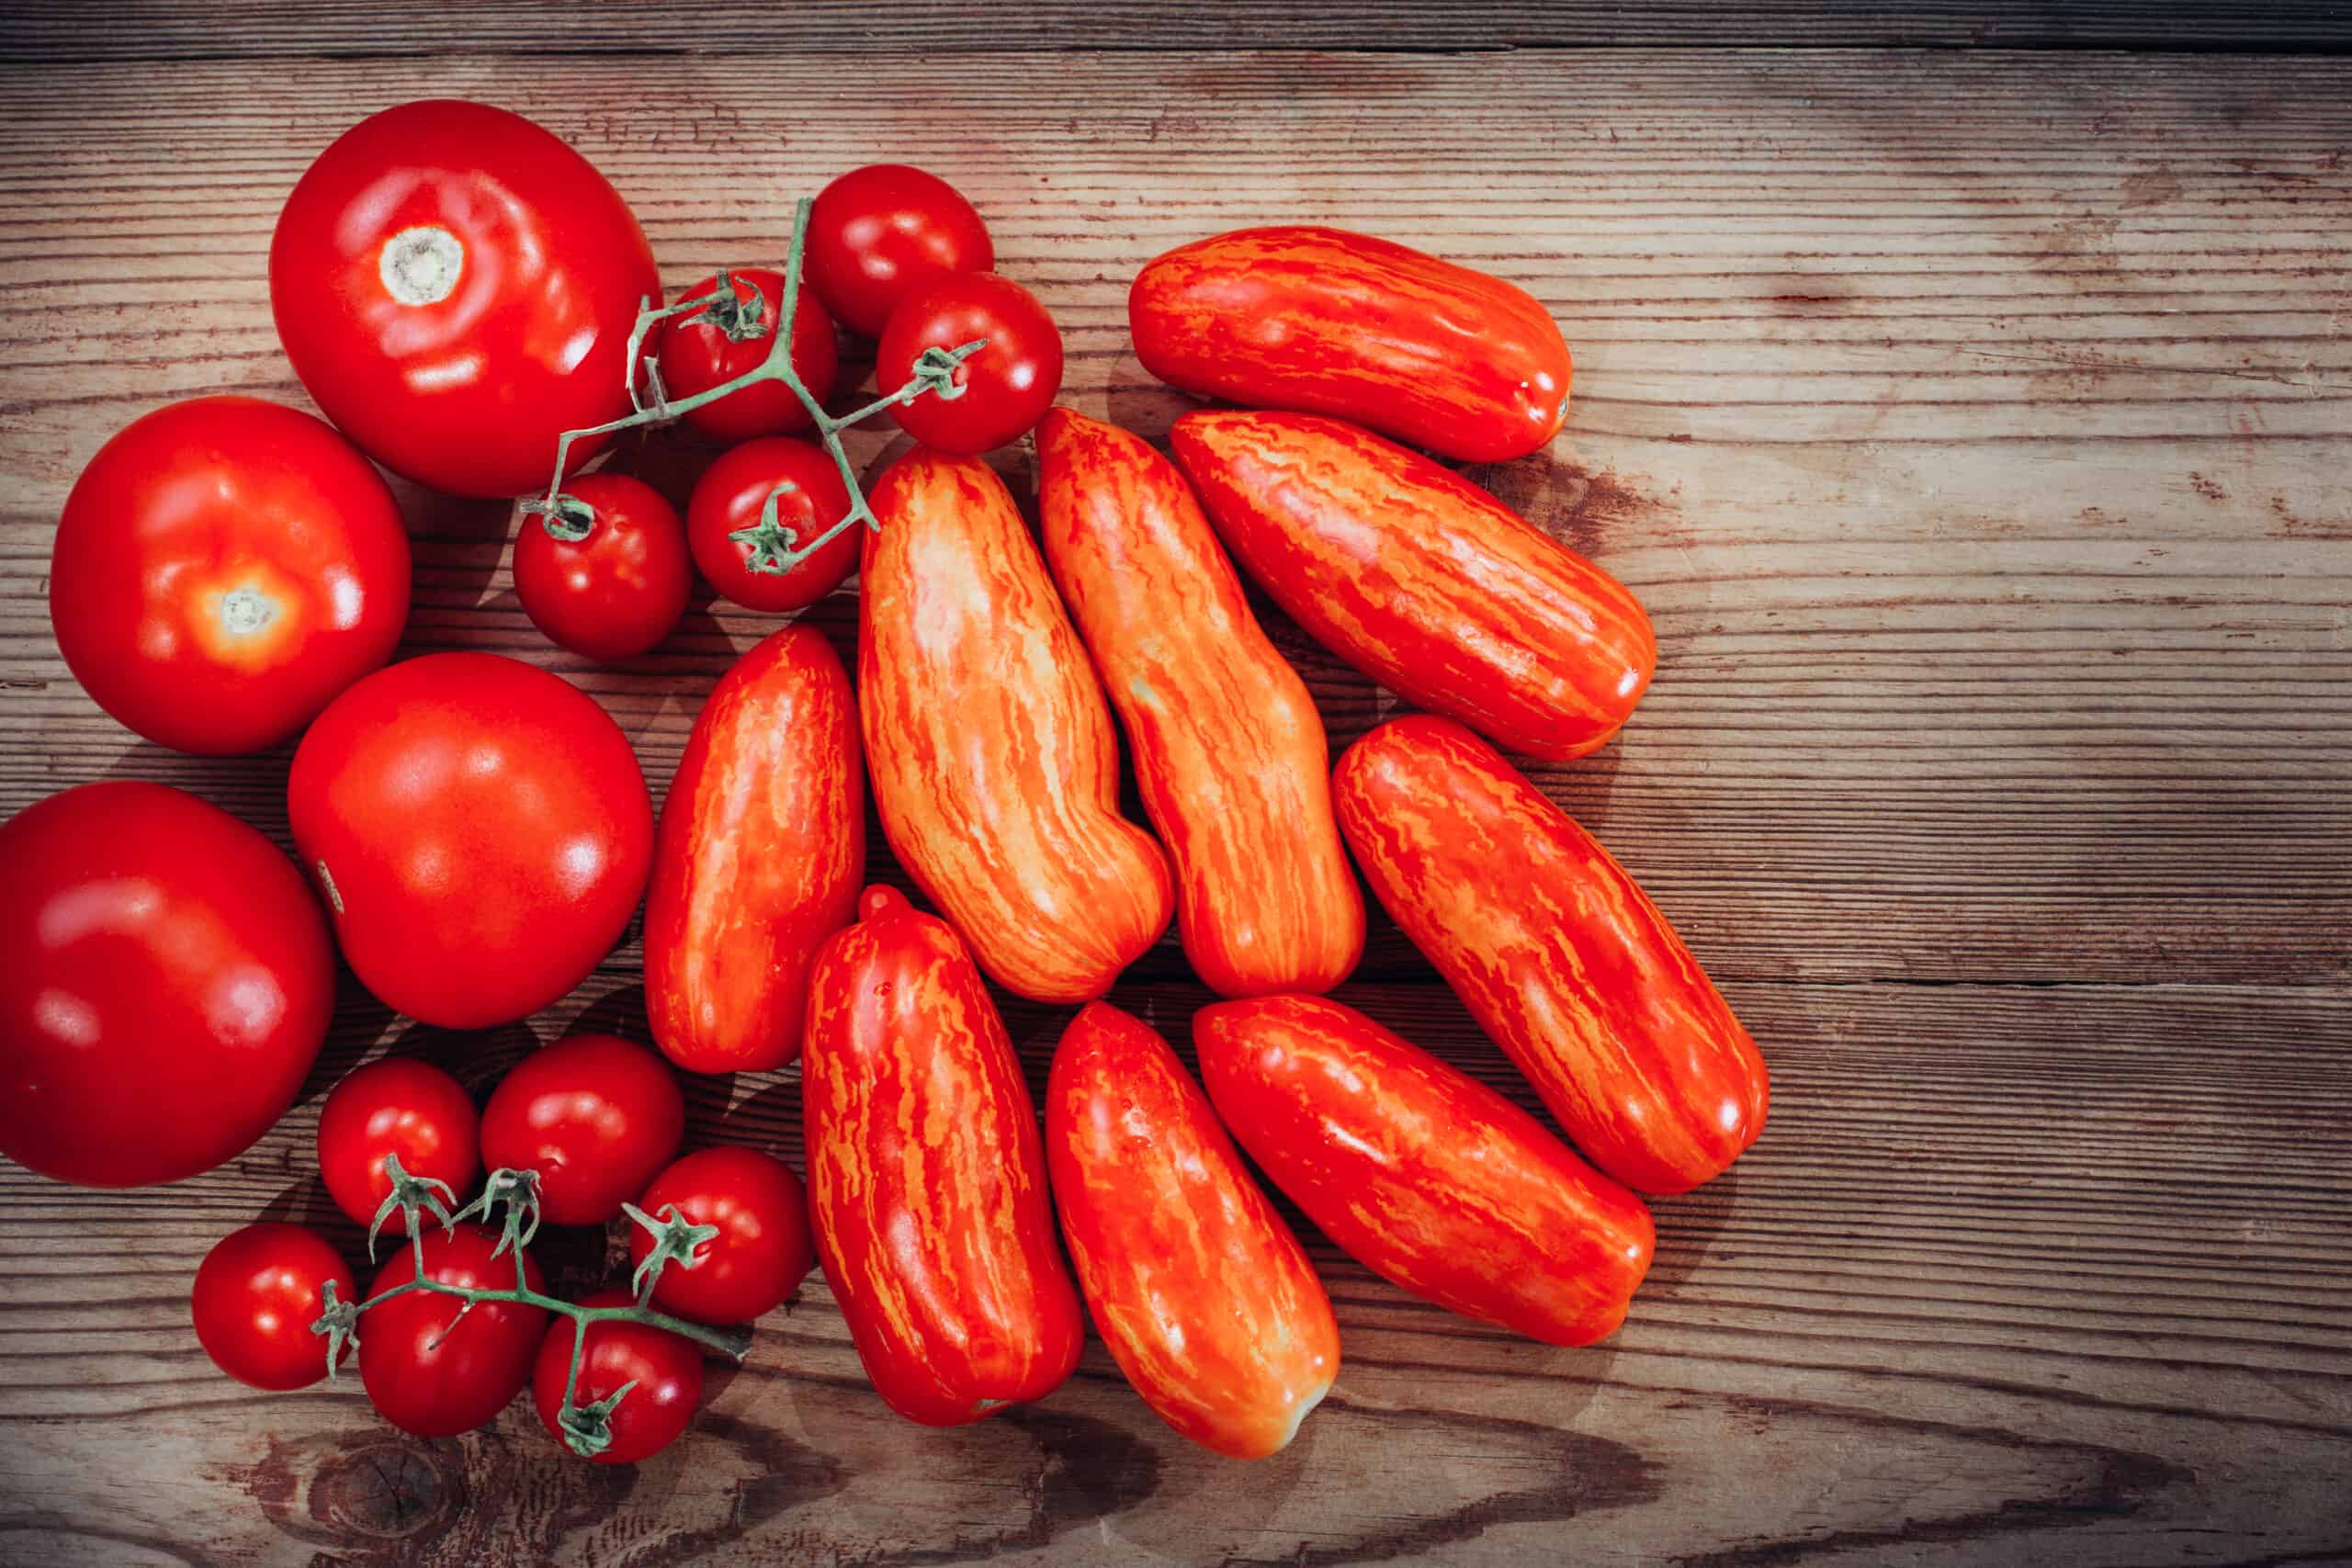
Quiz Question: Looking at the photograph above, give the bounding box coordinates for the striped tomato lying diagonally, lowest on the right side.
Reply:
[1193,997,1656,1345]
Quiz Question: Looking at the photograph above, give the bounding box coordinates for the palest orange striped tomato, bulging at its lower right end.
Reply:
[858,446,1173,1001]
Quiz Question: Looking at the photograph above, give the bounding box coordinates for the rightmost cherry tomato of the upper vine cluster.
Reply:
[875,273,1061,456]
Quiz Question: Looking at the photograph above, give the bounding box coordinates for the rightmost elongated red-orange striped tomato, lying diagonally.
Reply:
[1334,715,1771,1192]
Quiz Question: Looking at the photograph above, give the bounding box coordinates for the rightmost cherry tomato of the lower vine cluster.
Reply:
[628,1147,816,1324]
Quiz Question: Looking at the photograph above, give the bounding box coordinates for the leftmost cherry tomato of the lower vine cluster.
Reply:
[188,1224,357,1392]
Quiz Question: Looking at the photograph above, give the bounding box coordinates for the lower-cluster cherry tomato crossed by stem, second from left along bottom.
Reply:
[360,1224,548,1437]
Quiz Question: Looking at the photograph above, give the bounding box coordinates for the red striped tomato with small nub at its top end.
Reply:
[799,886,1087,1427]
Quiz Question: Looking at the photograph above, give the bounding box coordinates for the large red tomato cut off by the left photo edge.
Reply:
[0,781,334,1187]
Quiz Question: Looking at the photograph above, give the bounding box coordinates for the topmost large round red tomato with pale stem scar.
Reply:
[270,98,661,496]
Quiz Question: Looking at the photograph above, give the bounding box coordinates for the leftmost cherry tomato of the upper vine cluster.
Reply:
[515,472,694,663]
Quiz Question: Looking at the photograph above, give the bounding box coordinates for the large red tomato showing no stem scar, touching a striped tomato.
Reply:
[287,653,654,1030]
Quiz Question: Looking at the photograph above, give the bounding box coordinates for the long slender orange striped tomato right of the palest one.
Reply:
[1037,409,1364,997]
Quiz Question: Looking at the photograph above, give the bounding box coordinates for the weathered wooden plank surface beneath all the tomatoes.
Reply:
[0,17,2352,1568]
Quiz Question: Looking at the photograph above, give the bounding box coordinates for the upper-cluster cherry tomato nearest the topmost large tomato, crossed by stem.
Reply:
[661,265,842,442]
